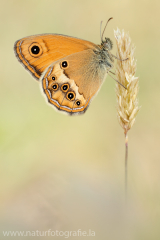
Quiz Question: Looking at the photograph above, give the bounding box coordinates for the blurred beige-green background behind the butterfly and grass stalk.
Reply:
[0,0,160,240]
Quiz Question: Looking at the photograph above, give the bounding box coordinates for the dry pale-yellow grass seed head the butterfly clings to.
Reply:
[114,29,139,135]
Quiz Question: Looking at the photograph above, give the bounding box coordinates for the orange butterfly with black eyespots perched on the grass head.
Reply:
[14,18,115,115]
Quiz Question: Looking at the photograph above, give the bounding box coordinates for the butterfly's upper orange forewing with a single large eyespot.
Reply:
[14,34,97,79]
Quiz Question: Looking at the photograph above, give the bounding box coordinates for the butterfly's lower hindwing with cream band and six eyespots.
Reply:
[40,49,106,114]
